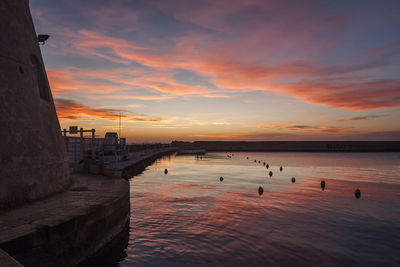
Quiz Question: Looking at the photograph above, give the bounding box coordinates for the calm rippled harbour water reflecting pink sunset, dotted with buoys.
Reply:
[120,153,400,266]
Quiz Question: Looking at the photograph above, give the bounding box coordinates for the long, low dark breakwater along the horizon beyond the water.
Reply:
[171,141,400,152]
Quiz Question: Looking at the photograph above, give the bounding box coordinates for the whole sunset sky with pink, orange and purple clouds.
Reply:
[30,0,400,143]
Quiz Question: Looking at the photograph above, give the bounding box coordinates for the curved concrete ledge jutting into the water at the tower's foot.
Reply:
[0,174,130,266]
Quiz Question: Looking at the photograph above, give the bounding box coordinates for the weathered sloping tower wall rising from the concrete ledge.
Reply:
[0,0,70,209]
